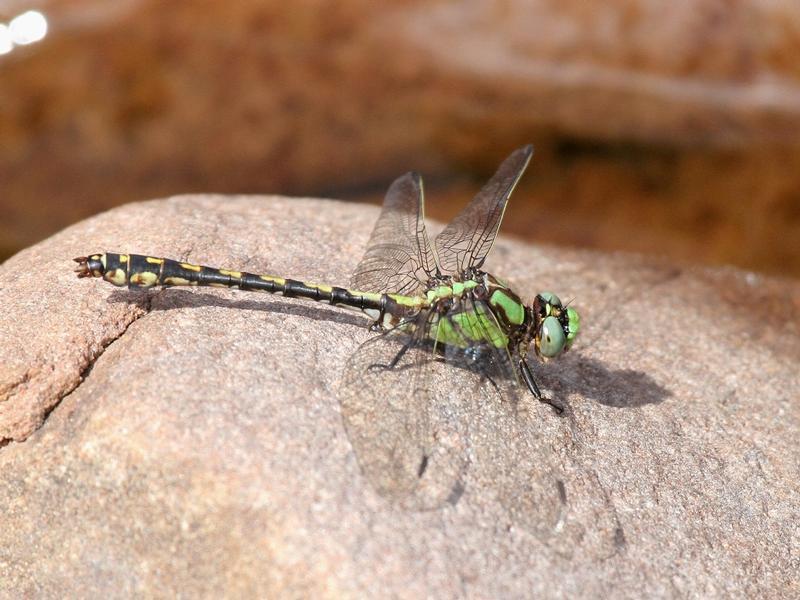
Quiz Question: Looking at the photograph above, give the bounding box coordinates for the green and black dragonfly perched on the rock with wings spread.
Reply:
[75,146,580,506]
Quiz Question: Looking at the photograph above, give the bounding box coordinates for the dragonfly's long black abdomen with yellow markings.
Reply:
[75,252,387,318]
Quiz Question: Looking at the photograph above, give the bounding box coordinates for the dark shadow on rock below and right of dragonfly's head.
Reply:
[536,355,672,408]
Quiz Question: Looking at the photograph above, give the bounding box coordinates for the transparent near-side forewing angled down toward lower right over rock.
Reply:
[446,300,625,556]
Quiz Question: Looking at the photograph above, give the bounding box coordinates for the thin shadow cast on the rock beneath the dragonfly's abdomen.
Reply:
[108,289,369,328]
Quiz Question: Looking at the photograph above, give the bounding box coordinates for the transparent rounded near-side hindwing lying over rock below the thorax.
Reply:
[339,311,467,510]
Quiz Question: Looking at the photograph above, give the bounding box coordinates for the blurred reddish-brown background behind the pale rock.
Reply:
[0,0,800,277]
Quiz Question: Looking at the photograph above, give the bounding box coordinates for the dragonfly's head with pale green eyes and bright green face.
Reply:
[528,292,581,359]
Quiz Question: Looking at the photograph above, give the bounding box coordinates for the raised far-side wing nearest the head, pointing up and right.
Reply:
[435,145,533,274]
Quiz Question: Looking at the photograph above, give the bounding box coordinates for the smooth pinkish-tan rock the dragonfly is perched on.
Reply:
[0,196,800,598]
